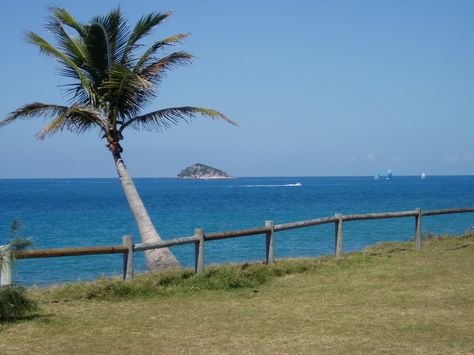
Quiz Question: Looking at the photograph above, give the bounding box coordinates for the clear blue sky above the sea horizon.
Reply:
[0,0,474,178]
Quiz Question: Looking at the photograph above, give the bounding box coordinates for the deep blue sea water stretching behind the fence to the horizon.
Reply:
[0,176,474,286]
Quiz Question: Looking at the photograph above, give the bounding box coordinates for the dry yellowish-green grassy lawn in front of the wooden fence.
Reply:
[0,235,474,354]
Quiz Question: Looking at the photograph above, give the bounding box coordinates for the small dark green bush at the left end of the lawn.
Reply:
[0,286,38,323]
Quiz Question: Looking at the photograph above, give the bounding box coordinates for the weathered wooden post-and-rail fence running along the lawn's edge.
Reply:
[0,207,474,286]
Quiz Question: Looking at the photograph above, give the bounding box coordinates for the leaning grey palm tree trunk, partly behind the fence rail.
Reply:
[112,152,181,271]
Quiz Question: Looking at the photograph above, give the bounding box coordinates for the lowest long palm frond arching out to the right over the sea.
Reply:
[120,106,239,132]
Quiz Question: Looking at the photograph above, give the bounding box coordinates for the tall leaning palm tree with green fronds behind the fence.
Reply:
[0,7,237,270]
